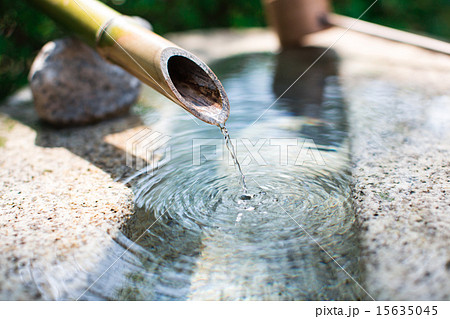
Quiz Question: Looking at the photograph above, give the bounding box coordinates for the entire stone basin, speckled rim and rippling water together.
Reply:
[0,28,450,300]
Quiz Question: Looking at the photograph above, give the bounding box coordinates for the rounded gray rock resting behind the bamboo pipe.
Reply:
[28,38,141,126]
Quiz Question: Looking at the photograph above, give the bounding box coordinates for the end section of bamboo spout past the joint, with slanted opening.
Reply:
[96,16,230,126]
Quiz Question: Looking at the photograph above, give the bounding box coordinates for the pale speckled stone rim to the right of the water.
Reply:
[302,29,450,300]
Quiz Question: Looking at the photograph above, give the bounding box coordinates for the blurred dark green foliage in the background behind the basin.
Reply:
[0,0,450,99]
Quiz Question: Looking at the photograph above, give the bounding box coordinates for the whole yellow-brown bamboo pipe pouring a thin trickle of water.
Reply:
[28,0,230,126]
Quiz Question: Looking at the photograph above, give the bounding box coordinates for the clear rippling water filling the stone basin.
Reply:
[92,48,365,300]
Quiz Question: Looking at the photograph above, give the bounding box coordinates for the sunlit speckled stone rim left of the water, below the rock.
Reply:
[0,89,141,300]
